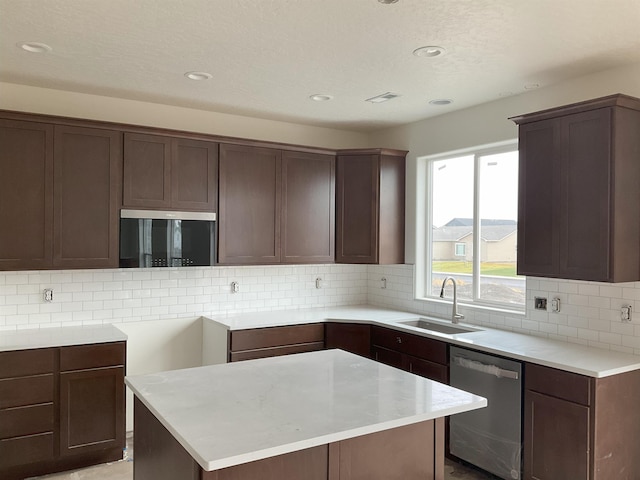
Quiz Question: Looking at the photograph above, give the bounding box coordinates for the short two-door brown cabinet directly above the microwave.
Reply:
[123,133,218,212]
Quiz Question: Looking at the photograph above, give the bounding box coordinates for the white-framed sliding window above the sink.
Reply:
[424,144,526,309]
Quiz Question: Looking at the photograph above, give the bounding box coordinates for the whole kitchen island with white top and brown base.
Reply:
[126,350,486,480]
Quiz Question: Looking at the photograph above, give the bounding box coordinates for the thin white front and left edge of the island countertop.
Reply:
[125,378,487,471]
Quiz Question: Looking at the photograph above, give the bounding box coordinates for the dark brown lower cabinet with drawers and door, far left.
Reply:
[0,342,126,480]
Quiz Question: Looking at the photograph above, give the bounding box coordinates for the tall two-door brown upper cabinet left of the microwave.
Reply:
[0,120,122,270]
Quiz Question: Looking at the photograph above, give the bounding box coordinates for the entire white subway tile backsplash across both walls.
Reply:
[0,264,640,355]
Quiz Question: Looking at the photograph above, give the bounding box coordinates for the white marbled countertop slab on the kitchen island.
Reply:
[125,350,487,471]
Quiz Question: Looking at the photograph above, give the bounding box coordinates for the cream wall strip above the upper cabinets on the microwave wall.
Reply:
[0,82,368,148]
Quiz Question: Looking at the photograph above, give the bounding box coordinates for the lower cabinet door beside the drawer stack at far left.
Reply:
[60,366,124,456]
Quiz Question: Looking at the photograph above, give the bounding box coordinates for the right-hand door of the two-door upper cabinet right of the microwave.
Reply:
[281,152,335,263]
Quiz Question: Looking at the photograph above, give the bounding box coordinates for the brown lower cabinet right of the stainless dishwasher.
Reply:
[523,364,640,480]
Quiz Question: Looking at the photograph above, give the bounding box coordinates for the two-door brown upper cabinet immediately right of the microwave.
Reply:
[218,144,335,265]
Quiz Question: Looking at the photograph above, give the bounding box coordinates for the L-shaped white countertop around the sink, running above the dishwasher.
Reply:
[206,305,640,378]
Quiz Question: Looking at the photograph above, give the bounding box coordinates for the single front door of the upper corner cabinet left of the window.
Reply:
[336,155,380,263]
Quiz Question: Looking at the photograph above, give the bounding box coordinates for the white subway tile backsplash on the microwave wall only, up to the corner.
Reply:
[0,264,367,331]
